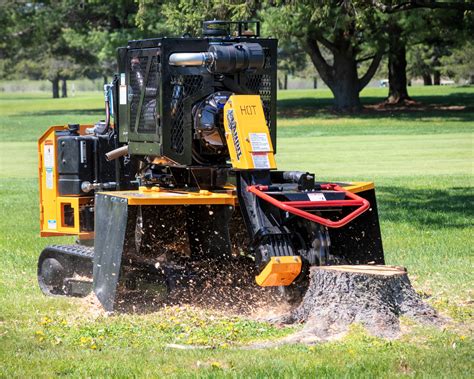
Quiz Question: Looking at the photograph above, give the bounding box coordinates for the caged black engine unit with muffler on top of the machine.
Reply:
[114,21,277,179]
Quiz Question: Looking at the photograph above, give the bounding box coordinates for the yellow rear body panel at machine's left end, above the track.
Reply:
[38,125,93,239]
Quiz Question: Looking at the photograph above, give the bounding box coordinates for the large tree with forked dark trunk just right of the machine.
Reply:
[263,0,386,112]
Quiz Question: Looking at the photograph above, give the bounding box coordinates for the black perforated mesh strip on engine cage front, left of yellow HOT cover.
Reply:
[171,75,203,154]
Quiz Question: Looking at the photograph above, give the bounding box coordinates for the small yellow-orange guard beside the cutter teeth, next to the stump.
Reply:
[255,255,301,287]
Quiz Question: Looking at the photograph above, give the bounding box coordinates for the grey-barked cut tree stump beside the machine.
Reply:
[286,265,441,342]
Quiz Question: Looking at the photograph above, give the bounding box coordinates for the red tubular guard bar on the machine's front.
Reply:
[247,184,370,228]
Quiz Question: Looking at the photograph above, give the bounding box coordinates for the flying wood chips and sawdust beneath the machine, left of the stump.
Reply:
[116,256,291,319]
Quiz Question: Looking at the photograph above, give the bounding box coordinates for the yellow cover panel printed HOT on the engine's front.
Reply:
[224,95,276,170]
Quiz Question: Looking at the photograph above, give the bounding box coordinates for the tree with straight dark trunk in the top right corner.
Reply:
[372,0,474,104]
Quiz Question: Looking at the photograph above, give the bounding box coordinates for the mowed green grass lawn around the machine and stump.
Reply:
[0,87,474,378]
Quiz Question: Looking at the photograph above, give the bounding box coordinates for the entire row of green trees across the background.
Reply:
[0,0,474,105]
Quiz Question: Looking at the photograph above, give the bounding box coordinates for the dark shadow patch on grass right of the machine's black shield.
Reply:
[377,186,474,229]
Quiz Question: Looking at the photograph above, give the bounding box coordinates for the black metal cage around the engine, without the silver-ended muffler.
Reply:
[117,36,277,165]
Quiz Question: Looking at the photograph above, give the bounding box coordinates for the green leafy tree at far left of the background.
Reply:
[0,0,144,98]
